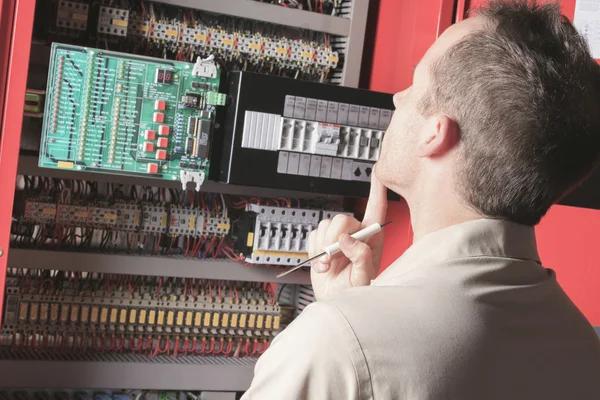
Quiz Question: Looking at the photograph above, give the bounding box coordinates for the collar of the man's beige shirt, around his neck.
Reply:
[372,219,540,285]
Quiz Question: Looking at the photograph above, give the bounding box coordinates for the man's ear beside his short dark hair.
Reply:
[417,115,460,157]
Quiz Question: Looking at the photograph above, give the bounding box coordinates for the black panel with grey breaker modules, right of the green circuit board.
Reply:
[215,72,393,197]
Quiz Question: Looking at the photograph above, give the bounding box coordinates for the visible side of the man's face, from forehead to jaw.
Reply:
[375,17,483,196]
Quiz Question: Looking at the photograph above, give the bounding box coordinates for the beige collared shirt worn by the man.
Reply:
[243,220,600,400]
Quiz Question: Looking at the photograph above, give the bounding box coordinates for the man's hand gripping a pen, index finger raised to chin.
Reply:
[308,173,387,300]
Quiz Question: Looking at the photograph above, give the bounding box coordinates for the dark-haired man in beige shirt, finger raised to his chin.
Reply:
[244,1,600,400]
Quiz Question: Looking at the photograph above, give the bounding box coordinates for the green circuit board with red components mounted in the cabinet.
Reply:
[39,43,226,190]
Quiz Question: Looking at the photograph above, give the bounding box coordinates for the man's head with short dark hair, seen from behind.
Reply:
[376,1,600,225]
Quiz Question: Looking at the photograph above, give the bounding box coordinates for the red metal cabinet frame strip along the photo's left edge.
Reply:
[0,0,35,320]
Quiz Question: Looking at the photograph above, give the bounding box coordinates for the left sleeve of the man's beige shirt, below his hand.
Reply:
[242,302,360,400]
